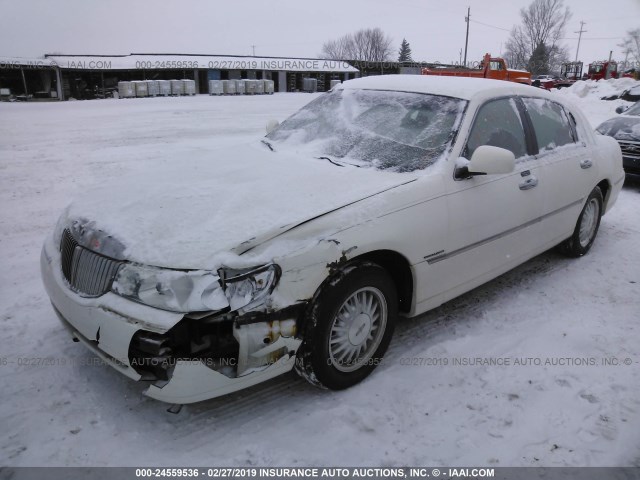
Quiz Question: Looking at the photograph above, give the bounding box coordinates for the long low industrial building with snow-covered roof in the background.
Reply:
[0,53,359,100]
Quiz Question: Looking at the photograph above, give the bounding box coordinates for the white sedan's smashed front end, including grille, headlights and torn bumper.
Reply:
[41,222,322,404]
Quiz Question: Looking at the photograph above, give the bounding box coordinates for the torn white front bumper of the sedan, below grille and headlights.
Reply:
[40,236,301,404]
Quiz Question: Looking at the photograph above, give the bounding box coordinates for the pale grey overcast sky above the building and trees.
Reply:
[0,0,640,64]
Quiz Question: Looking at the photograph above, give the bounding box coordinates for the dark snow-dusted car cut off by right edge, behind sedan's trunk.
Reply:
[596,101,640,175]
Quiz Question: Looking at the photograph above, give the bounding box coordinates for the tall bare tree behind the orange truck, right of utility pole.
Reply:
[505,0,571,73]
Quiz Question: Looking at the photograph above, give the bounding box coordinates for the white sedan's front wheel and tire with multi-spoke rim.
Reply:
[296,262,398,390]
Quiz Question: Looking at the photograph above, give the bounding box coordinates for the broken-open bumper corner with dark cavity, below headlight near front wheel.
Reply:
[128,303,306,404]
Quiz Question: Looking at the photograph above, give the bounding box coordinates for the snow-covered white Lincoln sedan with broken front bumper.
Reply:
[41,75,624,404]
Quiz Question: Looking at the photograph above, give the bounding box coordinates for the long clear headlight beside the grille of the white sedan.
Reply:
[111,264,229,312]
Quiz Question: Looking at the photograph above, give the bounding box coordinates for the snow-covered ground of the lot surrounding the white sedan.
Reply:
[0,87,640,466]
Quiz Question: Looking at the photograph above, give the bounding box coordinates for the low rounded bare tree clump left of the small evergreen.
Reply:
[320,28,393,62]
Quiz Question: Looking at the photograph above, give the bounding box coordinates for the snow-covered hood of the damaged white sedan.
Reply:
[59,142,416,269]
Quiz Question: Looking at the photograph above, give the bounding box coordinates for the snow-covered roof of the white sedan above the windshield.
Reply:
[342,75,546,100]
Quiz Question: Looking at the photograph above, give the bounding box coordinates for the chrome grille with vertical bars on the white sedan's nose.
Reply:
[60,230,122,297]
